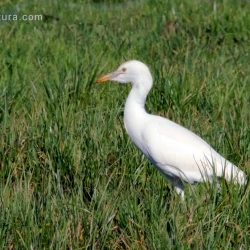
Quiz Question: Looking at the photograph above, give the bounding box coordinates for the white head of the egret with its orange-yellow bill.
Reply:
[96,60,152,85]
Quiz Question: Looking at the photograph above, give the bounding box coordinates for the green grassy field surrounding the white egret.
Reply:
[0,0,250,250]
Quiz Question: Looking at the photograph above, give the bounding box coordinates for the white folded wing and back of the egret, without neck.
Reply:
[140,115,246,183]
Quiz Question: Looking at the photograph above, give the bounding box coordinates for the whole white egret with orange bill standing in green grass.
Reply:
[97,60,246,197]
